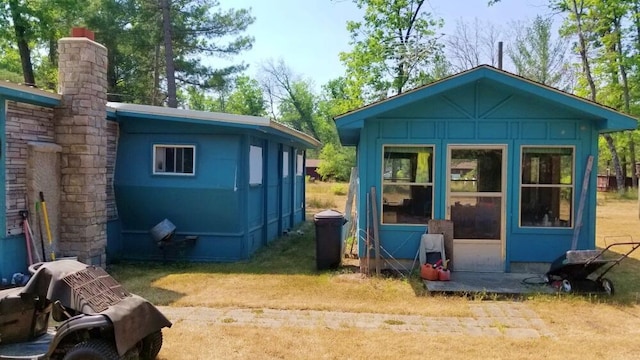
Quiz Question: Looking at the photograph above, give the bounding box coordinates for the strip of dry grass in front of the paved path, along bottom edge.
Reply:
[160,324,640,360]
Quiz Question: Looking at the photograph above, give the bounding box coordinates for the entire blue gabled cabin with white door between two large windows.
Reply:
[336,66,637,272]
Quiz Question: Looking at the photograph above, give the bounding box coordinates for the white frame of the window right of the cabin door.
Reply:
[518,145,576,230]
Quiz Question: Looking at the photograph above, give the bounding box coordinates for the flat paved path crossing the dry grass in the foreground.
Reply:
[159,302,554,338]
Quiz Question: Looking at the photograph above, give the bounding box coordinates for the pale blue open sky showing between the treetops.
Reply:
[221,0,549,88]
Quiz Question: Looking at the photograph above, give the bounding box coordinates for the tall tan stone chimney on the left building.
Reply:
[55,29,107,267]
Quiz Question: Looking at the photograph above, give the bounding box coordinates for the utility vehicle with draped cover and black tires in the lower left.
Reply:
[0,260,171,360]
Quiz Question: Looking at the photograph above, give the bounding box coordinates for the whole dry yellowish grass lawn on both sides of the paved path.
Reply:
[113,184,640,360]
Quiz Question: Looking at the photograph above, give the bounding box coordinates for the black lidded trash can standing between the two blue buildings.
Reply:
[313,210,345,270]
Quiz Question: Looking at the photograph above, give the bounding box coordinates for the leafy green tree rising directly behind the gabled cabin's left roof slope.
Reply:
[340,0,442,102]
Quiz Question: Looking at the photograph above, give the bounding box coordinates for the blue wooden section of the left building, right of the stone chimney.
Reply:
[107,103,319,261]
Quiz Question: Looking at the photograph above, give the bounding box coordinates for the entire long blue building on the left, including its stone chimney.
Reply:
[0,32,319,280]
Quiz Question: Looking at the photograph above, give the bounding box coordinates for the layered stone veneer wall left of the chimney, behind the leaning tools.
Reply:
[5,101,54,234]
